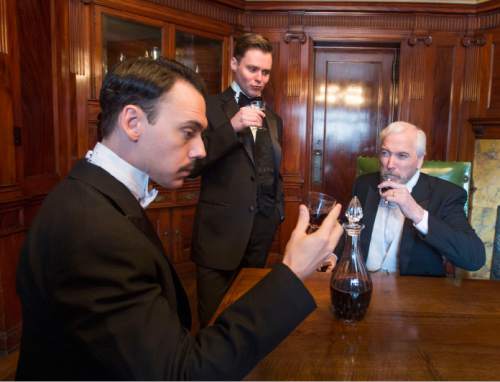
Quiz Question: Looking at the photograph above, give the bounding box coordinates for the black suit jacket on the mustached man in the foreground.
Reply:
[17,161,314,380]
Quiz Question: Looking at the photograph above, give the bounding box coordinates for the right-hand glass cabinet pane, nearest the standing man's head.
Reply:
[175,31,222,94]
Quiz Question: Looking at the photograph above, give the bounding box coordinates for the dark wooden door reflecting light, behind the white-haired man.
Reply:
[310,46,398,207]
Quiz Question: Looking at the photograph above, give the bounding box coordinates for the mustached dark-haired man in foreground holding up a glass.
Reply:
[17,58,342,380]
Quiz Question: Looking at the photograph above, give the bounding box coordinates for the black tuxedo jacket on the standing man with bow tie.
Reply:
[192,88,284,270]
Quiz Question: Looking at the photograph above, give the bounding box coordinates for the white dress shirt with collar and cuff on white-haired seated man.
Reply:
[366,171,429,272]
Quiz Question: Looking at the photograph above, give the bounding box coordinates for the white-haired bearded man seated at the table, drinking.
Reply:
[353,121,485,276]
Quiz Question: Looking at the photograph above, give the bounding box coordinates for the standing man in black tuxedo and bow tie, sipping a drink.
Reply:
[192,33,284,326]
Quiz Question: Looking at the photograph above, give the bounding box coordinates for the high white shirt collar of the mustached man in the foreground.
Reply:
[85,142,158,208]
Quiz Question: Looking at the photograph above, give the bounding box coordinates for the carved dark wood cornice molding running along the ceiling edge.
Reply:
[88,0,500,32]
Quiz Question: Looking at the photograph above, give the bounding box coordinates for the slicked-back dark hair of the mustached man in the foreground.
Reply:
[98,57,206,137]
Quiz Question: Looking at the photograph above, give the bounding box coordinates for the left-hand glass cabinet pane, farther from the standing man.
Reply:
[102,15,161,74]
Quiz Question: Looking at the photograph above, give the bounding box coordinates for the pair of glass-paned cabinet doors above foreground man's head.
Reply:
[94,7,229,98]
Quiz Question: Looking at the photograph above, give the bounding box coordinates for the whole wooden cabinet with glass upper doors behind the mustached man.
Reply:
[87,6,231,269]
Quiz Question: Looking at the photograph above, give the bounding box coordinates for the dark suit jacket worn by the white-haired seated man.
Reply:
[353,173,485,276]
